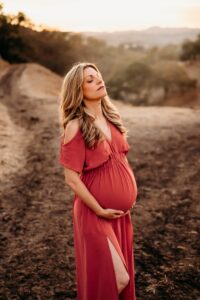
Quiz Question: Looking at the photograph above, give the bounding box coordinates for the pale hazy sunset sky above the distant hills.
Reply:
[1,0,200,31]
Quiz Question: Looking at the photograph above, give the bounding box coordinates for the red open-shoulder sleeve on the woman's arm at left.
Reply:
[59,130,85,173]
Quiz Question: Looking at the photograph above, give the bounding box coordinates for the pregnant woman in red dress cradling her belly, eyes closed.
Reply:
[59,63,137,300]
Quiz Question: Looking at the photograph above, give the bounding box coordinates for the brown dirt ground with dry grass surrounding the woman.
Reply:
[0,64,200,300]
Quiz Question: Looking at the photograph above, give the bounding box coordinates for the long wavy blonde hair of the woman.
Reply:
[59,62,128,148]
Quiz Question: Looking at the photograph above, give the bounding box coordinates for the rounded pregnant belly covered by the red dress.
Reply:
[83,161,137,212]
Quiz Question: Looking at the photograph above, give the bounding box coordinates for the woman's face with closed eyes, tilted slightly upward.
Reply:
[82,67,107,100]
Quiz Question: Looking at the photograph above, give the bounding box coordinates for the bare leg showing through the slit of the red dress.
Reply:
[107,237,130,294]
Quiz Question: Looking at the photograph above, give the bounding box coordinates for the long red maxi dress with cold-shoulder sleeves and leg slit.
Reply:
[59,121,137,300]
